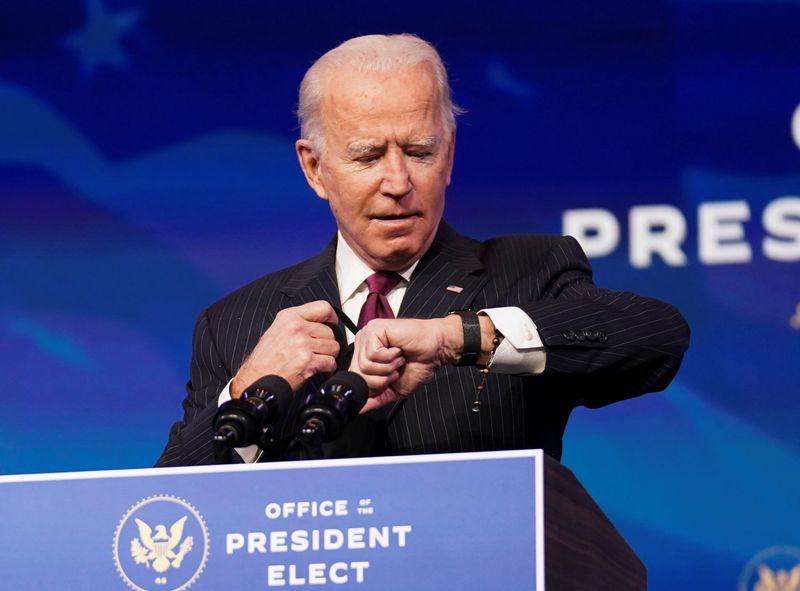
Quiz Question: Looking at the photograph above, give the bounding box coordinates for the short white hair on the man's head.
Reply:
[297,33,463,150]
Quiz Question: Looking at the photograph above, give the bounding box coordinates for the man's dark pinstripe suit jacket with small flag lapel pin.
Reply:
[158,222,689,466]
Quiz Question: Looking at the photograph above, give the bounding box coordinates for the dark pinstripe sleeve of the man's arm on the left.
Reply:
[156,310,234,466]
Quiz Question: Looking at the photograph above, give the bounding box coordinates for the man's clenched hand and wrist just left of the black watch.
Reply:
[350,316,464,413]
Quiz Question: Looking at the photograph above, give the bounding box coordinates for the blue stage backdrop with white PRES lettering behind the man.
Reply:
[0,0,800,591]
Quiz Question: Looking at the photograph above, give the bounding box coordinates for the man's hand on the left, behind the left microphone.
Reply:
[230,300,339,398]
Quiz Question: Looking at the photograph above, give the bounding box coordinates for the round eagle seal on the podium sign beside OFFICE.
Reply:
[114,495,209,591]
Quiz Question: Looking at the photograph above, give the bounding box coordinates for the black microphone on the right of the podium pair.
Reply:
[298,371,369,442]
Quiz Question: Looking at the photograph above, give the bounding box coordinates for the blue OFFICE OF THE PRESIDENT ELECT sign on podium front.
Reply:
[0,450,544,591]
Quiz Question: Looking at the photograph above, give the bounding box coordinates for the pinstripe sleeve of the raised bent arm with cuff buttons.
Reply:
[519,236,689,407]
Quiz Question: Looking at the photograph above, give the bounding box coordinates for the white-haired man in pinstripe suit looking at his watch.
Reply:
[158,35,688,465]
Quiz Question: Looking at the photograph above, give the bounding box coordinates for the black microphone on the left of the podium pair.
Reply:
[213,375,293,454]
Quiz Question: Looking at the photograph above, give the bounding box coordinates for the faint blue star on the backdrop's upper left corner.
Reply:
[63,0,142,75]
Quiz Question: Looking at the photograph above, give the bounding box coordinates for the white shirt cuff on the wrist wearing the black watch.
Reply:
[478,306,547,375]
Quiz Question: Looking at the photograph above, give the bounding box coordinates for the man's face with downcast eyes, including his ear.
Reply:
[297,63,455,271]
